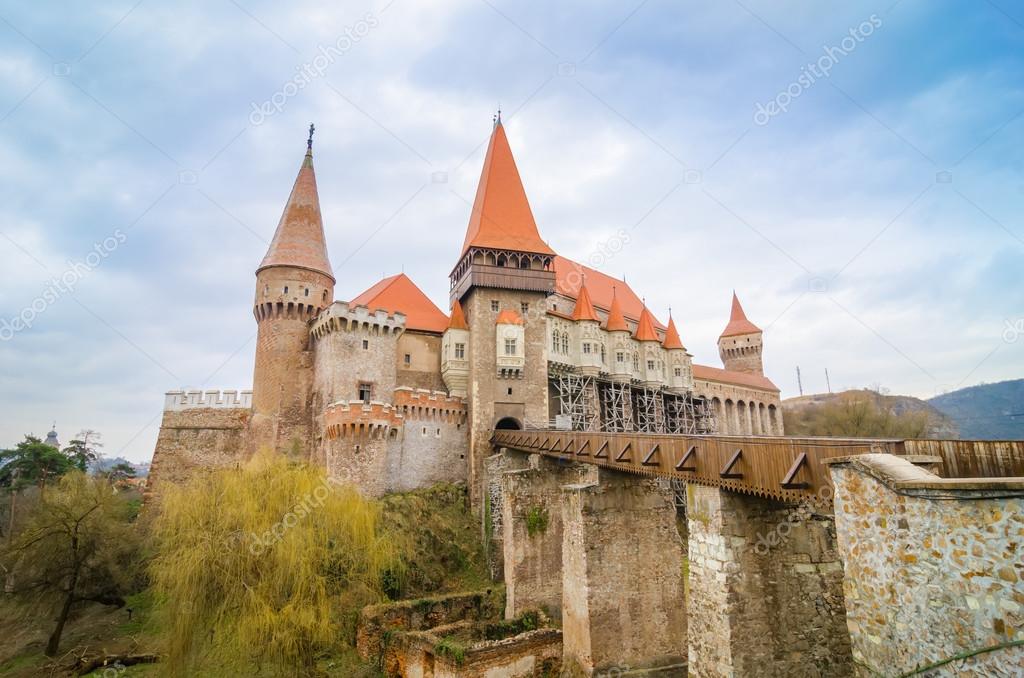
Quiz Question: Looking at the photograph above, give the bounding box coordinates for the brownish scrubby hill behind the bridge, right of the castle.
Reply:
[782,389,961,438]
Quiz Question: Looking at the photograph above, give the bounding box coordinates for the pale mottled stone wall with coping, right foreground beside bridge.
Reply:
[829,455,1024,676]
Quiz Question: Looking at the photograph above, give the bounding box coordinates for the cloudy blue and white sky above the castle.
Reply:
[0,0,1024,461]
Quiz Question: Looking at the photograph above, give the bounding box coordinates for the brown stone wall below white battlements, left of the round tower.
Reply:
[146,408,252,499]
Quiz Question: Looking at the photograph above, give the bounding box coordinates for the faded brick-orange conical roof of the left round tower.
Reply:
[256,151,334,281]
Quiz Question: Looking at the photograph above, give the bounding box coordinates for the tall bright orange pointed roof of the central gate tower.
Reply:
[462,120,555,259]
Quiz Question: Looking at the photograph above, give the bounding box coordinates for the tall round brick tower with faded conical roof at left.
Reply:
[251,125,335,451]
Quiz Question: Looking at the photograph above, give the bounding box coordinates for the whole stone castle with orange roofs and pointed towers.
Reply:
[152,117,782,497]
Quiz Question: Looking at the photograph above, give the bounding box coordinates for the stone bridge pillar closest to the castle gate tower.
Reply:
[501,455,597,619]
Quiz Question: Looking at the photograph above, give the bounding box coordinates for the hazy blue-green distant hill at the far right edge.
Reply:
[928,379,1024,440]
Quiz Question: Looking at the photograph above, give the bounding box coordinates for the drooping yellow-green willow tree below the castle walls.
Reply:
[151,455,400,675]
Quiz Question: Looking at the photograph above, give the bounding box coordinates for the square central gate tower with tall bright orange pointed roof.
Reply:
[450,116,555,504]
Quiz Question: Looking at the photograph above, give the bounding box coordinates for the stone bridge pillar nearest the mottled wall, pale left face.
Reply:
[686,484,853,678]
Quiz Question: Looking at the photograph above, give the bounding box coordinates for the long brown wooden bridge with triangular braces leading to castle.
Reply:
[492,429,1024,501]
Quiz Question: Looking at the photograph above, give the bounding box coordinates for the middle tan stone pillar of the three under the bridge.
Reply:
[562,469,686,676]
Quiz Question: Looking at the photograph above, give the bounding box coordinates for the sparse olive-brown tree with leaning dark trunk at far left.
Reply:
[0,470,137,656]
